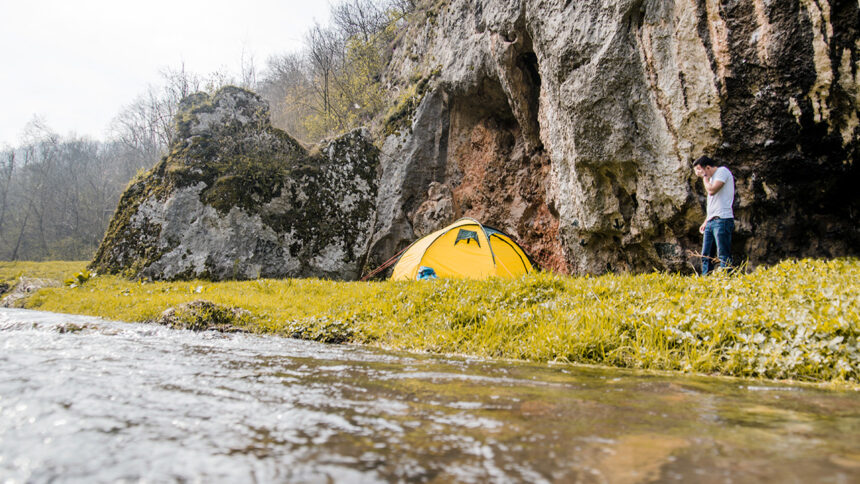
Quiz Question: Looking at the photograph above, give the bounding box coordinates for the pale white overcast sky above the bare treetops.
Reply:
[0,0,330,148]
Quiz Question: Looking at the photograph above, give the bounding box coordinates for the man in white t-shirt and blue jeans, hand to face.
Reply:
[693,156,735,276]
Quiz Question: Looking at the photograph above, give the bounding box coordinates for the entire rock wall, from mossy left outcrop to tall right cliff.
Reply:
[93,0,860,279]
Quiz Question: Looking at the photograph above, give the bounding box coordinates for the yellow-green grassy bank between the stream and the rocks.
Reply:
[3,259,860,383]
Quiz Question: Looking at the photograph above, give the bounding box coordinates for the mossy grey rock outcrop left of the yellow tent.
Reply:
[91,87,379,280]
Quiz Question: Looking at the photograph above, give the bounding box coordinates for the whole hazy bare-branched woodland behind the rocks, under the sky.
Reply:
[0,0,419,260]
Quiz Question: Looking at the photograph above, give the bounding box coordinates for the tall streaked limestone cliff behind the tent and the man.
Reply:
[370,0,860,273]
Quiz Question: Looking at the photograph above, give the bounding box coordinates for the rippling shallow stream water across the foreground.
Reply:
[0,309,860,483]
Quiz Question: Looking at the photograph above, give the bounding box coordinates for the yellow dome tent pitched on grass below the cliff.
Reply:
[391,218,535,281]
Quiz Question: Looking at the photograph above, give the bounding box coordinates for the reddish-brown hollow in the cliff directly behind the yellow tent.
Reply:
[426,71,566,271]
